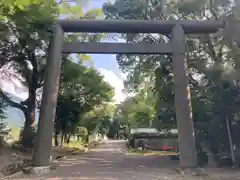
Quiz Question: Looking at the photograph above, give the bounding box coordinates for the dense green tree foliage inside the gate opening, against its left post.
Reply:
[55,59,114,143]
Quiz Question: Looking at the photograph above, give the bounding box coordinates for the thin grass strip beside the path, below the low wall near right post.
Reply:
[125,149,177,156]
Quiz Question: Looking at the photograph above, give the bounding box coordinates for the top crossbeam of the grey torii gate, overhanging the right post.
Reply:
[57,20,223,34]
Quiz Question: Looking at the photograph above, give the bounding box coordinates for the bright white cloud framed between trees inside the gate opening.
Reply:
[98,68,126,103]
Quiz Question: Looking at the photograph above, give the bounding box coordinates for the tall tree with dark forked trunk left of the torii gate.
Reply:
[0,0,105,146]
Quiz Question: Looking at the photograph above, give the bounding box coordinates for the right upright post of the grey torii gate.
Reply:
[172,25,197,168]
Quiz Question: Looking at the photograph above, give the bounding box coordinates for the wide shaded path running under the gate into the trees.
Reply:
[14,141,240,180]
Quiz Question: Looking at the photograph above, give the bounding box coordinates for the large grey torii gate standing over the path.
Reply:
[33,20,223,168]
